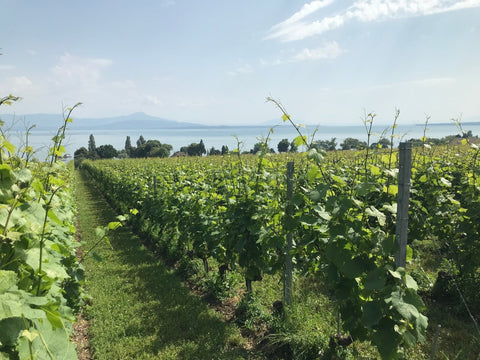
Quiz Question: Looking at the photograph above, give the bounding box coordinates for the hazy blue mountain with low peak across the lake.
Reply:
[0,112,205,130]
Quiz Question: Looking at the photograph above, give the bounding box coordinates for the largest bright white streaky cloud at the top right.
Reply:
[266,0,480,42]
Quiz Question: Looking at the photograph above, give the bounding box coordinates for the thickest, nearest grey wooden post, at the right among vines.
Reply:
[395,142,412,268]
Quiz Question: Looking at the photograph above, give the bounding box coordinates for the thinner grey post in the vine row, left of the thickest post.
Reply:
[283,161,294,306]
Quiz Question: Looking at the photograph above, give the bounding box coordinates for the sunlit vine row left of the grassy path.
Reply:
[0,96,83,359]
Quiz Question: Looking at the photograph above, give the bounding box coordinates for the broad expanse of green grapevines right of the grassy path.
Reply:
[77,137,479,358]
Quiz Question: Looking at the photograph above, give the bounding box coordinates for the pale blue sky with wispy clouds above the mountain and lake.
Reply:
[0,0,480,125]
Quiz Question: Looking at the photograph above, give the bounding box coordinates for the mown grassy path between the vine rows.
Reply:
[76,172,254,360]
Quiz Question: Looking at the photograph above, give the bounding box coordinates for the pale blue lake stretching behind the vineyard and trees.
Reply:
[10,122,480,159]
